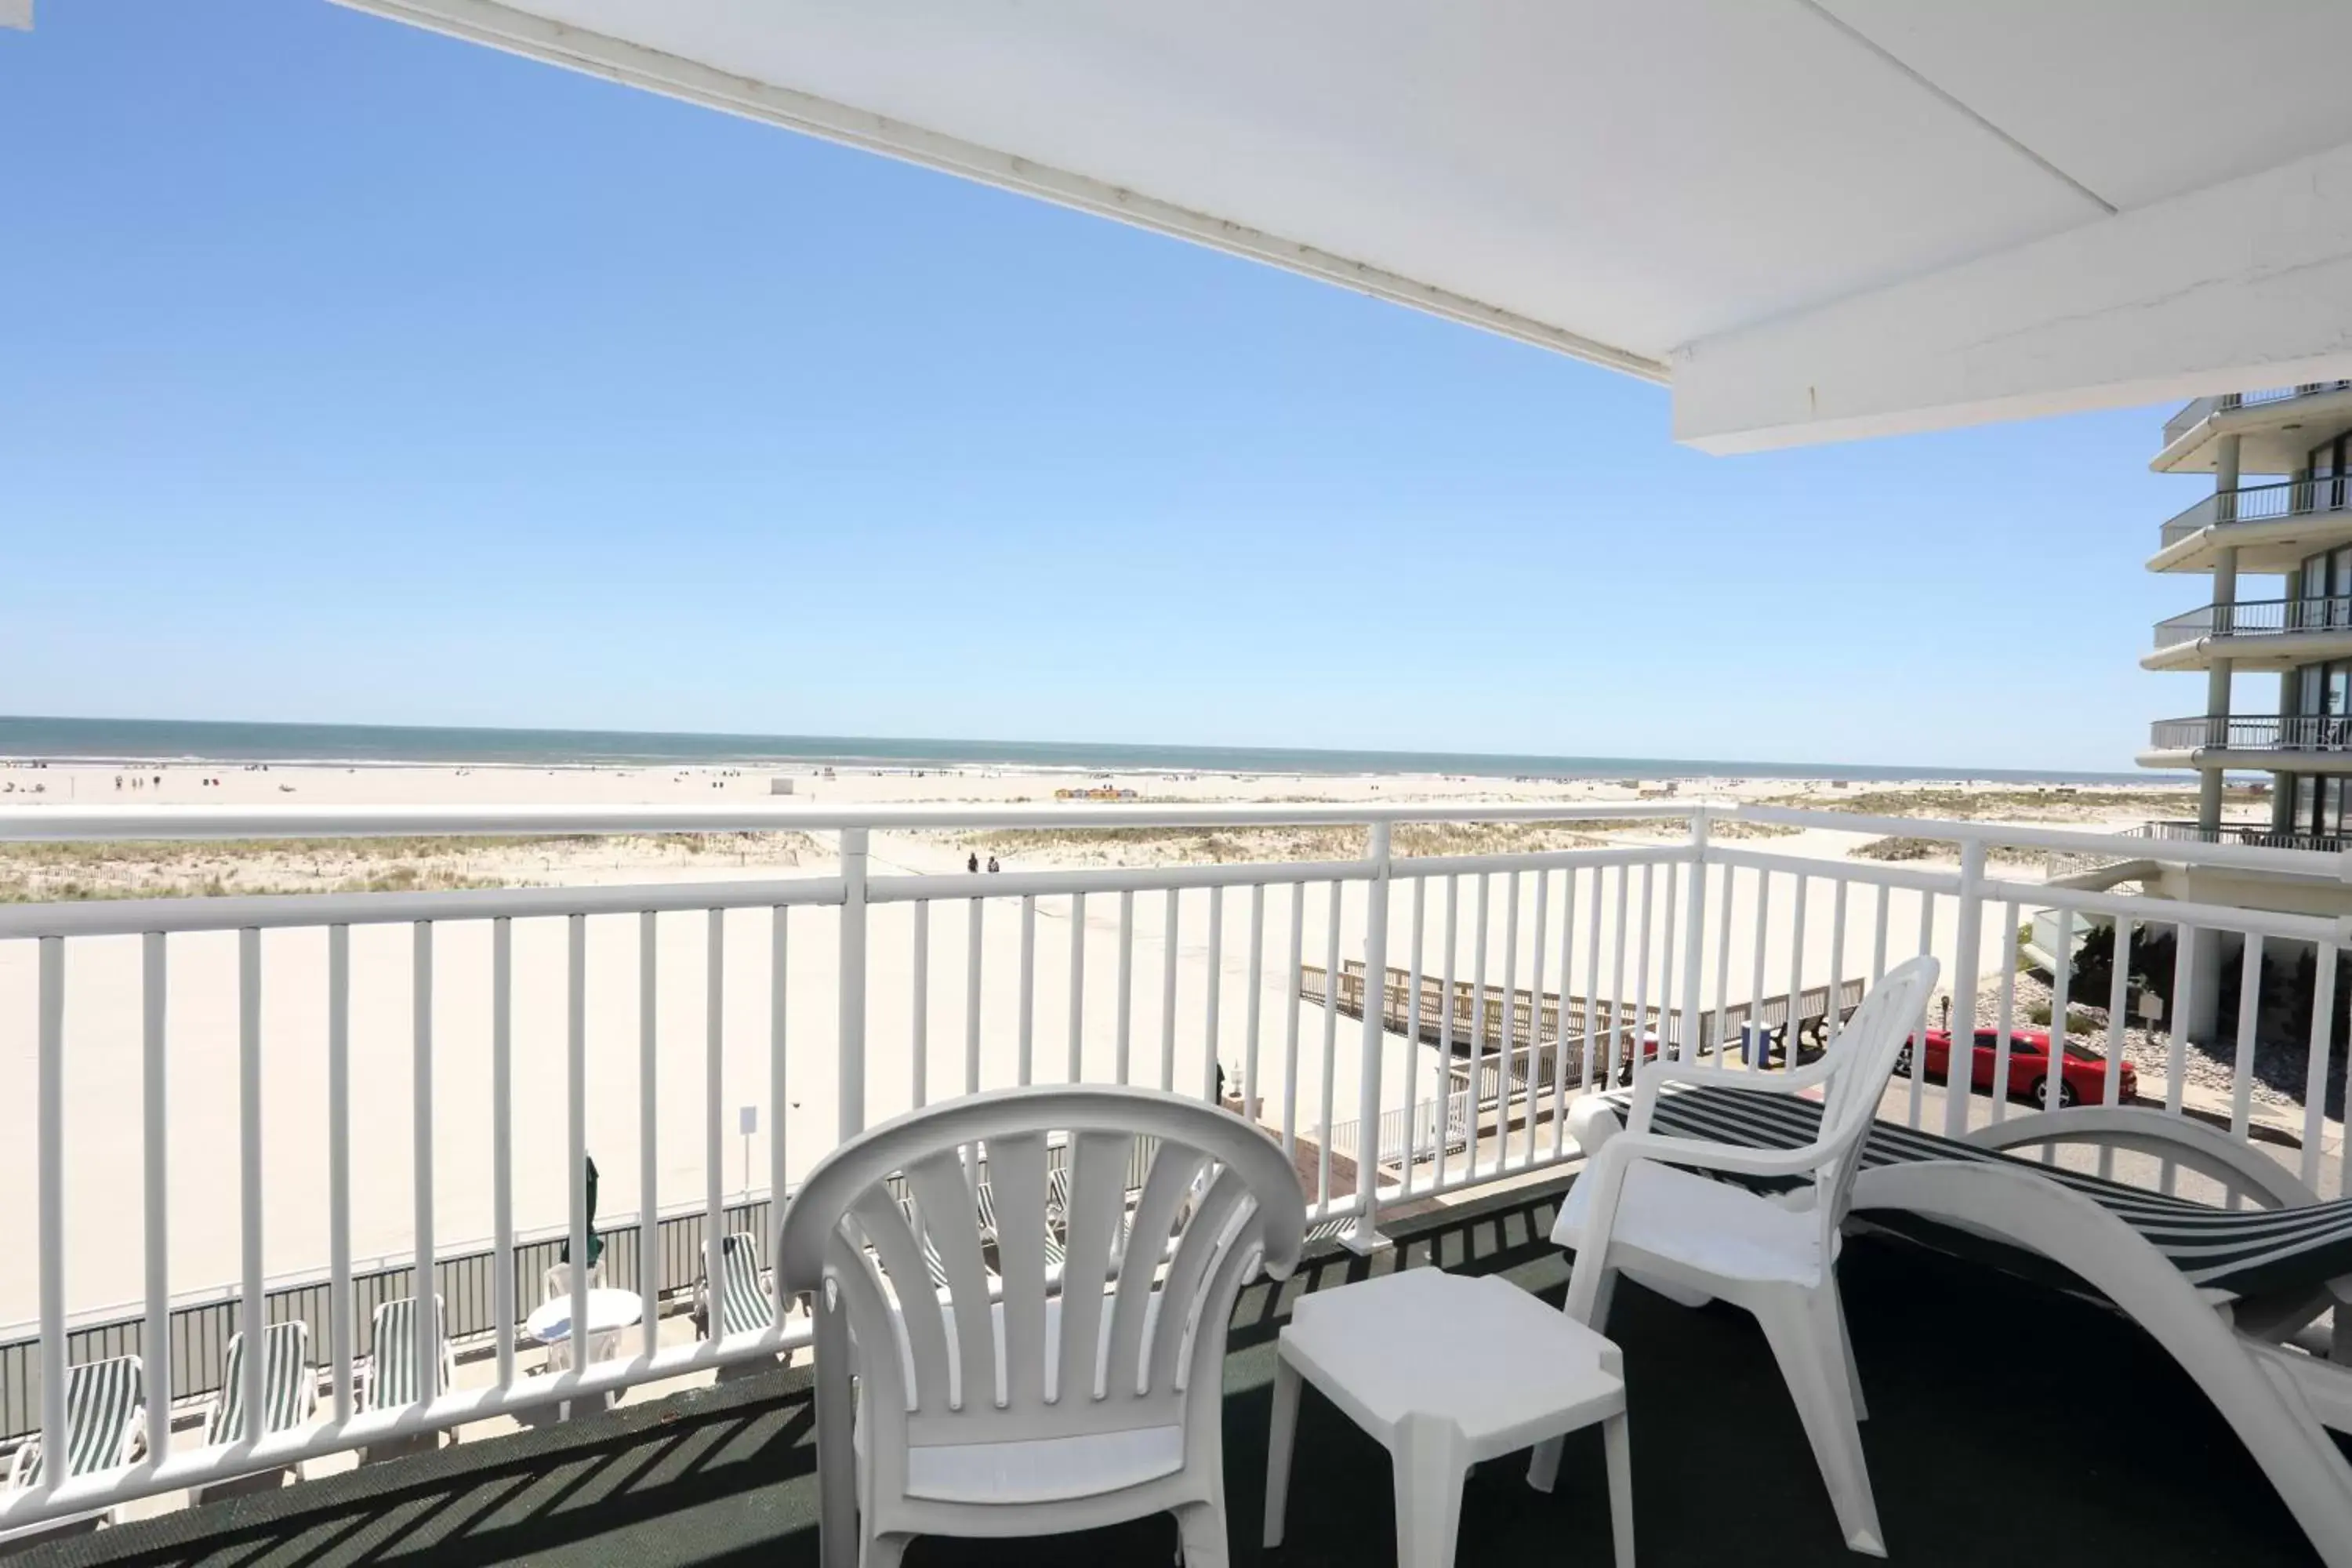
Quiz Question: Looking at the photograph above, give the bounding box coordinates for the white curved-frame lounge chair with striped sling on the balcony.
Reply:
[1571,1086,2352,1568]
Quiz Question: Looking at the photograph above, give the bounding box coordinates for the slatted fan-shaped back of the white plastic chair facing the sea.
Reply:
[776,1088,1305,1502]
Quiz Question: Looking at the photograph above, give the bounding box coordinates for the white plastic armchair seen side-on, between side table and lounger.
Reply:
[1526,956,1938,1556]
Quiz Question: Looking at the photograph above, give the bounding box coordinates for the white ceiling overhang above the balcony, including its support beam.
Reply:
[336,0,2352,452]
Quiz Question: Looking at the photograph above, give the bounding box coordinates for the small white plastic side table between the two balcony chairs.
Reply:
[1265,1267,1632,1568]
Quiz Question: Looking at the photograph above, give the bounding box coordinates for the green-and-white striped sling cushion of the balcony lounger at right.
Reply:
[1606,1086,2352,1295]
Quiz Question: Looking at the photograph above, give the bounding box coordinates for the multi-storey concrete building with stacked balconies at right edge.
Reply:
[2140,381,2352,853]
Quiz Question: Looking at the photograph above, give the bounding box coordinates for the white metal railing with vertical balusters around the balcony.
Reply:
[0,804,2340,1530]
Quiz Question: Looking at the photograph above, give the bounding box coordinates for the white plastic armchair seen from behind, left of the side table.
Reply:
[776,1088,1305,1568]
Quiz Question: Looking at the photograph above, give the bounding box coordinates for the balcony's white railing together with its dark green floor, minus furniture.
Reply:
[0,804,2352,1568]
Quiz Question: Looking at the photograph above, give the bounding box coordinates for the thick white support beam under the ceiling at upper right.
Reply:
[1672,143,2352,452]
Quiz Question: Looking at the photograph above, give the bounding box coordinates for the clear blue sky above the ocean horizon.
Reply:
[0,0,2239,769]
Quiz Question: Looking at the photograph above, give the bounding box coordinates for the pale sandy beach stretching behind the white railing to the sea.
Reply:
[0,762,2190,1323]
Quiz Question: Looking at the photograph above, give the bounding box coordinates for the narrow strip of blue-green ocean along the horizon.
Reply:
[0,715,2150,785]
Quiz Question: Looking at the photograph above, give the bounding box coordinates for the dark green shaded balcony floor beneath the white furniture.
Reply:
[16,1185,2314,1568]
